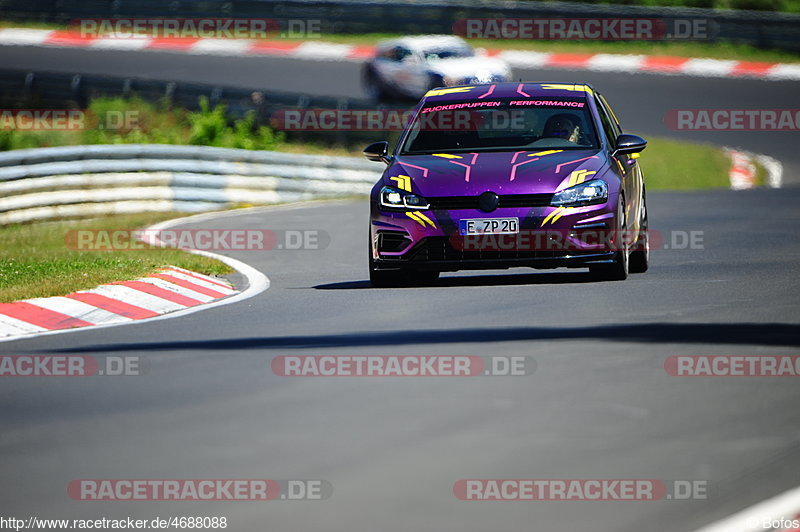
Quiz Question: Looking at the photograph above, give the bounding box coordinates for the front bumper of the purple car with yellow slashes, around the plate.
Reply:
[370,201,616,271]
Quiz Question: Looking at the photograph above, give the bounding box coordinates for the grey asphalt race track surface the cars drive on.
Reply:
[0,43,800,532]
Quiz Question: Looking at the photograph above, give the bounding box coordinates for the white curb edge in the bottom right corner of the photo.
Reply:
[695,488,800,532]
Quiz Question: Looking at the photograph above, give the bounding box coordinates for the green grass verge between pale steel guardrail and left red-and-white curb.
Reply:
[0,213,233,303]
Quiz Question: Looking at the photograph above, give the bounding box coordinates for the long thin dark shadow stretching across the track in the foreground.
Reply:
[50,323,800,353]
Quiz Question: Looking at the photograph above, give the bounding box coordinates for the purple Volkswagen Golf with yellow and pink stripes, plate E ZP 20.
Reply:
[364,82,649,287]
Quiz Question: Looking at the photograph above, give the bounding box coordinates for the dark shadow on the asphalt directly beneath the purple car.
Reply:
[313,272,598,290]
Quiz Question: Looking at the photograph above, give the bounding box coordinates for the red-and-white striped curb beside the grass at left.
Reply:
[0,267,238,337]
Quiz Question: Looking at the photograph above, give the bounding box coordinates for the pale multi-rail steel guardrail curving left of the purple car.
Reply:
[0,144,382,225]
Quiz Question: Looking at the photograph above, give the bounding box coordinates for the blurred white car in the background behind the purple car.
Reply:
[362,35,511,100]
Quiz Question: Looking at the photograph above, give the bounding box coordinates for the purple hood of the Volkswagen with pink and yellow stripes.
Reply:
[383,148,606,197]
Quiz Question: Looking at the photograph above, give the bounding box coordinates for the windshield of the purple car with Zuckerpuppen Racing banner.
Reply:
[400,98,598,155]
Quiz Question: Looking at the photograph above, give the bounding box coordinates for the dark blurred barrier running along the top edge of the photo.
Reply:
[0,0,800,50]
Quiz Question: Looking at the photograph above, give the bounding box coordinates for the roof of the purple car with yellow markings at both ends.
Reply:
[425,81,595,102]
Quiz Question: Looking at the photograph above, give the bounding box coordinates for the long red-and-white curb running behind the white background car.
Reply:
[0,28,800,80]
